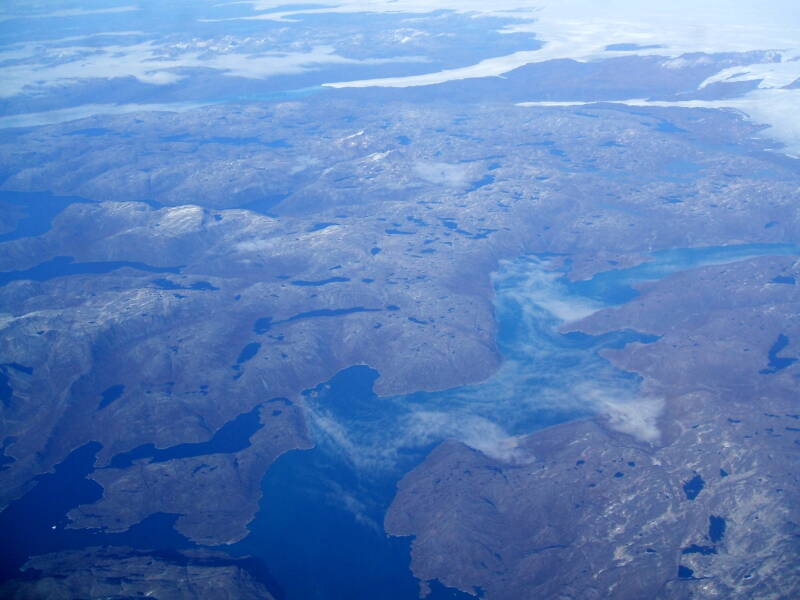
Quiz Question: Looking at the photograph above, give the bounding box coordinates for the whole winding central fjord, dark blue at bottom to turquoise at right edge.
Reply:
[230,245,800,600]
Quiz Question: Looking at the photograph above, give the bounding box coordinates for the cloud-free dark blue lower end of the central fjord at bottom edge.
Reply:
[234,450,418,600]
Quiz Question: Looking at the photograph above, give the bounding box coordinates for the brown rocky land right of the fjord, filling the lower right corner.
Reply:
[386,258,800,599]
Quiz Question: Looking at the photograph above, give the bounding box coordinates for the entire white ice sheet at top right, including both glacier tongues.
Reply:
[308,0,800,155]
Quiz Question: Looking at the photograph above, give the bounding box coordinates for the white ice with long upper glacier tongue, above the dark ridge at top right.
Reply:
[278,0,800,87]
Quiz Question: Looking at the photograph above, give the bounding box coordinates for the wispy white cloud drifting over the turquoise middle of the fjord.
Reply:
[300,259,662,472]
